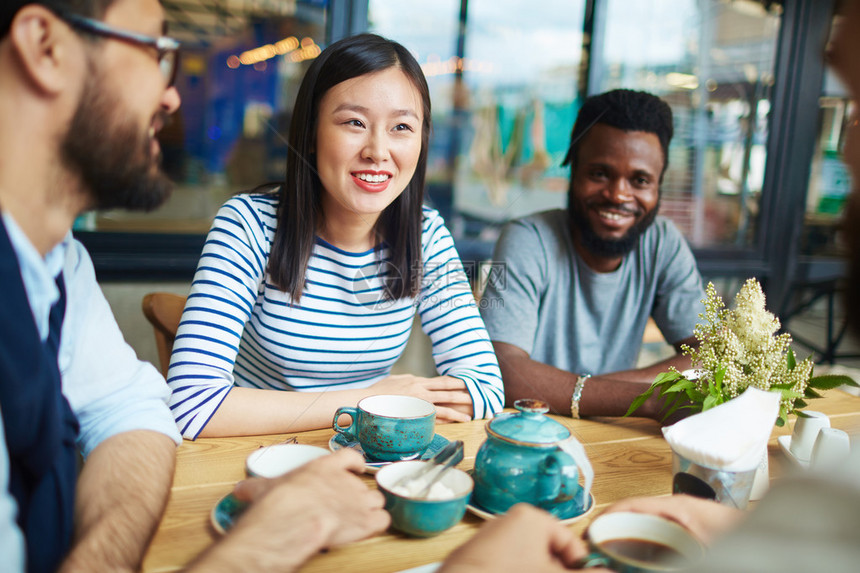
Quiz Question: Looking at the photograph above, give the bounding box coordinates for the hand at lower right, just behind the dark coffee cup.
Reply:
[604,494,746,545]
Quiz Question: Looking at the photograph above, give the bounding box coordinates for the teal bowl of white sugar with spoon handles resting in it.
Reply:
[376,460,474,537]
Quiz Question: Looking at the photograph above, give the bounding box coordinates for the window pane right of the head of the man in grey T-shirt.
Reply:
[589,0,780,247]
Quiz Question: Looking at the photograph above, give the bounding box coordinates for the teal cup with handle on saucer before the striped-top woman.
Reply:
[332,394,436,462]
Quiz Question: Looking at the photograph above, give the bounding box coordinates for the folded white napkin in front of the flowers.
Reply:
[663,388,780,472]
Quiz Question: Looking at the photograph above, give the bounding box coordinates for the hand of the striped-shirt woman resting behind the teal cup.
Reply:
[371,374,473,423]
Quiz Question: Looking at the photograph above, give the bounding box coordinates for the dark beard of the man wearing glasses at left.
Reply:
[60,66,173,211]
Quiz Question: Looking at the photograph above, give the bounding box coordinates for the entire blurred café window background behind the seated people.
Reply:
[76,0,856,370]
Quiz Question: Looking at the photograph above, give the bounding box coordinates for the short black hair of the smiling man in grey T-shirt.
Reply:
[562,90,674,180]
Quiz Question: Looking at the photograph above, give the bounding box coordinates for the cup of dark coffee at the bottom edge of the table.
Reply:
[577,511,704,573]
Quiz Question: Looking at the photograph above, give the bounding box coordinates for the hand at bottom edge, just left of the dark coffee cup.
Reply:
[439,504,605,573]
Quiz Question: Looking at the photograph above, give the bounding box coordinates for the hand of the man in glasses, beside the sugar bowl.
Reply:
[190,450,390,572]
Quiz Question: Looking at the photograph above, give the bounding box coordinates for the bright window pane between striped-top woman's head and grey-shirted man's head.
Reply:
[369,0,585,230]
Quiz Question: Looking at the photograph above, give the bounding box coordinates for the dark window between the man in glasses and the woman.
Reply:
[76,0,328,235]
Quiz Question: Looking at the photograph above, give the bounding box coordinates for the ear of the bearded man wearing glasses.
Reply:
[9,4,83,94]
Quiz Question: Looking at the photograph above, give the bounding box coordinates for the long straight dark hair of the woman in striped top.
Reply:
[268,34,430,302]
